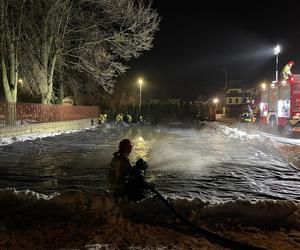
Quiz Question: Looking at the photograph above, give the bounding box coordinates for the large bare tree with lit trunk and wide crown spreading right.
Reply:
[22,0,159,103]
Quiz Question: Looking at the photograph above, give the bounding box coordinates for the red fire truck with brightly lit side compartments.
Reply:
[259,75,300,133]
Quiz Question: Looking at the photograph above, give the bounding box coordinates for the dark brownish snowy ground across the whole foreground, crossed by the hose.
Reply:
[0,191,300,249]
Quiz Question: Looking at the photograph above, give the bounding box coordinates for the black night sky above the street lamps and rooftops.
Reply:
[119,0,300,100]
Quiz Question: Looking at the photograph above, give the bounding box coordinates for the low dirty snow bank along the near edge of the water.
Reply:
[0,189,300,229]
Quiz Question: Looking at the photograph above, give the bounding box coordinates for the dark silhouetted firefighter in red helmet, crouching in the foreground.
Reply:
[107,139,134,196]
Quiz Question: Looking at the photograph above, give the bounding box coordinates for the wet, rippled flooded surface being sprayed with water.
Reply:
[0,124,300,202]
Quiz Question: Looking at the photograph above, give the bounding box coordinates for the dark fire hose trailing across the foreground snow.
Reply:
[149,187,267,250]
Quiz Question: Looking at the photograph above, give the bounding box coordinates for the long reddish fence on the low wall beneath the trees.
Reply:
[0,102,100,127]
